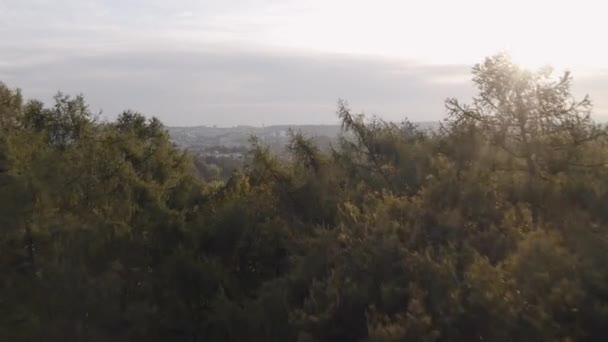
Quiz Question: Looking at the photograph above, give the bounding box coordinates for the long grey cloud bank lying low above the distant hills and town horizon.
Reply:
[0,40,478,125]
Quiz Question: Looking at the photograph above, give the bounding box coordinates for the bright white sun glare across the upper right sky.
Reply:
[258,0,608,70]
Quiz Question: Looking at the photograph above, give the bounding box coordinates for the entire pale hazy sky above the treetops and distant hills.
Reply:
[0,0,608,126]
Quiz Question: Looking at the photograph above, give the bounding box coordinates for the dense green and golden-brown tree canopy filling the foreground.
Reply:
[0,54,608,342]
